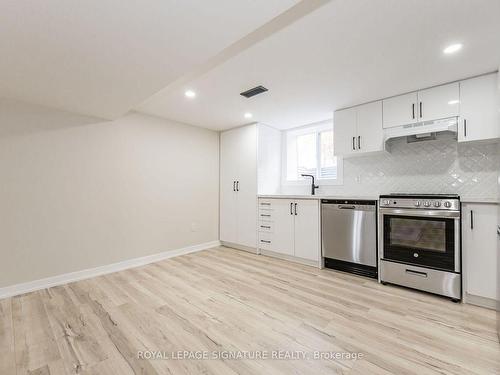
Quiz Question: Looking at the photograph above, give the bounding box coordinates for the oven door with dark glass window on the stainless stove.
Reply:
[380,208,460,272]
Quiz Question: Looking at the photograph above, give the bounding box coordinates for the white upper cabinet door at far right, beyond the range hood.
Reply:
[458,73,500,142]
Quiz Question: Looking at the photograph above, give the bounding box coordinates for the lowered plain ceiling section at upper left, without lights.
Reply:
[0,0,297,118]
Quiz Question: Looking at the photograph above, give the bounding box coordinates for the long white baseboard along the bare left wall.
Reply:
[0,241,220,299]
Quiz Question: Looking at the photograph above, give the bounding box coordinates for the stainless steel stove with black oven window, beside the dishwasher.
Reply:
[378,194,462,301]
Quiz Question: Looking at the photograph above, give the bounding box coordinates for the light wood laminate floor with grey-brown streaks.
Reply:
[0,248,500,375]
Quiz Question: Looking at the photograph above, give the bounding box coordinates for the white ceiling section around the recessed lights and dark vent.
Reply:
[136,0,500,129]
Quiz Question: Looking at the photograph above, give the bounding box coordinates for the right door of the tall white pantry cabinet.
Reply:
[235,125,257,248]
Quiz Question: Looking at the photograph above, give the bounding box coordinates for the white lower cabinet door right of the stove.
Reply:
[462,204,497,299]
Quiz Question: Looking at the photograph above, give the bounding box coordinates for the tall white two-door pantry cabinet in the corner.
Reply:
[220,125,257,249]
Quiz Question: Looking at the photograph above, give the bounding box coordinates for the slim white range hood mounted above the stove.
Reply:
[384,117,458,142]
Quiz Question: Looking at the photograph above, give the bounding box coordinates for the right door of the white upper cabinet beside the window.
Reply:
[356,101,384,152]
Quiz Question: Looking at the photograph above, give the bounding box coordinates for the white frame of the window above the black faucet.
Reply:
[281,120,344,186]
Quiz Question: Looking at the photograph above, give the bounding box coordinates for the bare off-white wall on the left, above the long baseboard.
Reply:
[0,105,219,287]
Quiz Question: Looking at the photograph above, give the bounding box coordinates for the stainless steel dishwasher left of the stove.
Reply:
[321,199,378,278]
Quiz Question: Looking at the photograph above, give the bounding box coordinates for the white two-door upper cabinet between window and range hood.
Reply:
[334,101,384,156]
